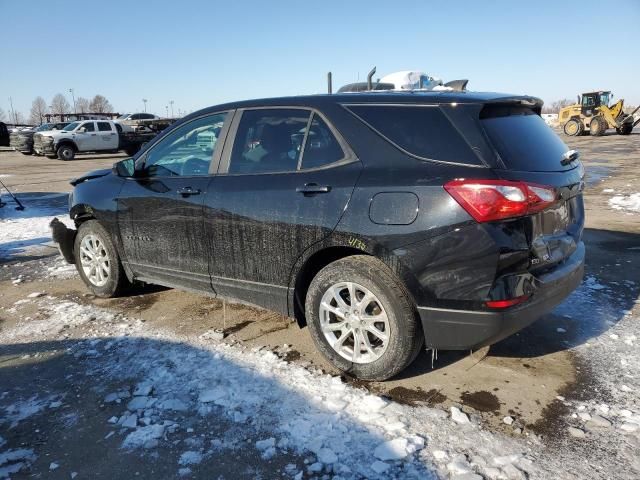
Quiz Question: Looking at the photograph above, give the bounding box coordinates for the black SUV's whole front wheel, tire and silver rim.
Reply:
[73,220,130,298]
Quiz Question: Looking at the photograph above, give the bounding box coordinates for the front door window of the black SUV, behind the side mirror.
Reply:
[144,113,227,177]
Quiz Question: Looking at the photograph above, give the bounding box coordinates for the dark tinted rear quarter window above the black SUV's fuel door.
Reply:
[348,105,480,165]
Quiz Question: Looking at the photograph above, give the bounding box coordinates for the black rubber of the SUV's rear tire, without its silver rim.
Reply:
[305,256,423,381]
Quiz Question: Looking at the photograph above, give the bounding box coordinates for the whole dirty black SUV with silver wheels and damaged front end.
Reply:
[54,92,585,380]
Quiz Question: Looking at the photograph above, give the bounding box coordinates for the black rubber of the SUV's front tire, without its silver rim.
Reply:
[73,220,125,298]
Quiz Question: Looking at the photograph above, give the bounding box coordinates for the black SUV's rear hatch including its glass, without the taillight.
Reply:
[480,105,584,271]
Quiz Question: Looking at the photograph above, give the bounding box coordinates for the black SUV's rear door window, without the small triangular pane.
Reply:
[229,108,309,173]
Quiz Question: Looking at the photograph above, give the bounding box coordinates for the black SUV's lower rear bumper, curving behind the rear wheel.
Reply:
[418,242,585,350]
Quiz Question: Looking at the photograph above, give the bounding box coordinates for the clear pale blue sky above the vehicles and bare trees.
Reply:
[0,0,640,116]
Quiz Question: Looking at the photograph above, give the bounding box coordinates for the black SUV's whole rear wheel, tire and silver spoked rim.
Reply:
[305,255,424,381]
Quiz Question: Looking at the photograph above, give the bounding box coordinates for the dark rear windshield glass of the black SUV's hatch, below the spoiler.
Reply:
[480,107,575,172]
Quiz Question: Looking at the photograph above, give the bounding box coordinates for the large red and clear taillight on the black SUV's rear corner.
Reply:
[444,179,557,222]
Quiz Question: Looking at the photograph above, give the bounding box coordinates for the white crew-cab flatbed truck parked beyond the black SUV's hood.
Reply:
[33,120,156,160]
